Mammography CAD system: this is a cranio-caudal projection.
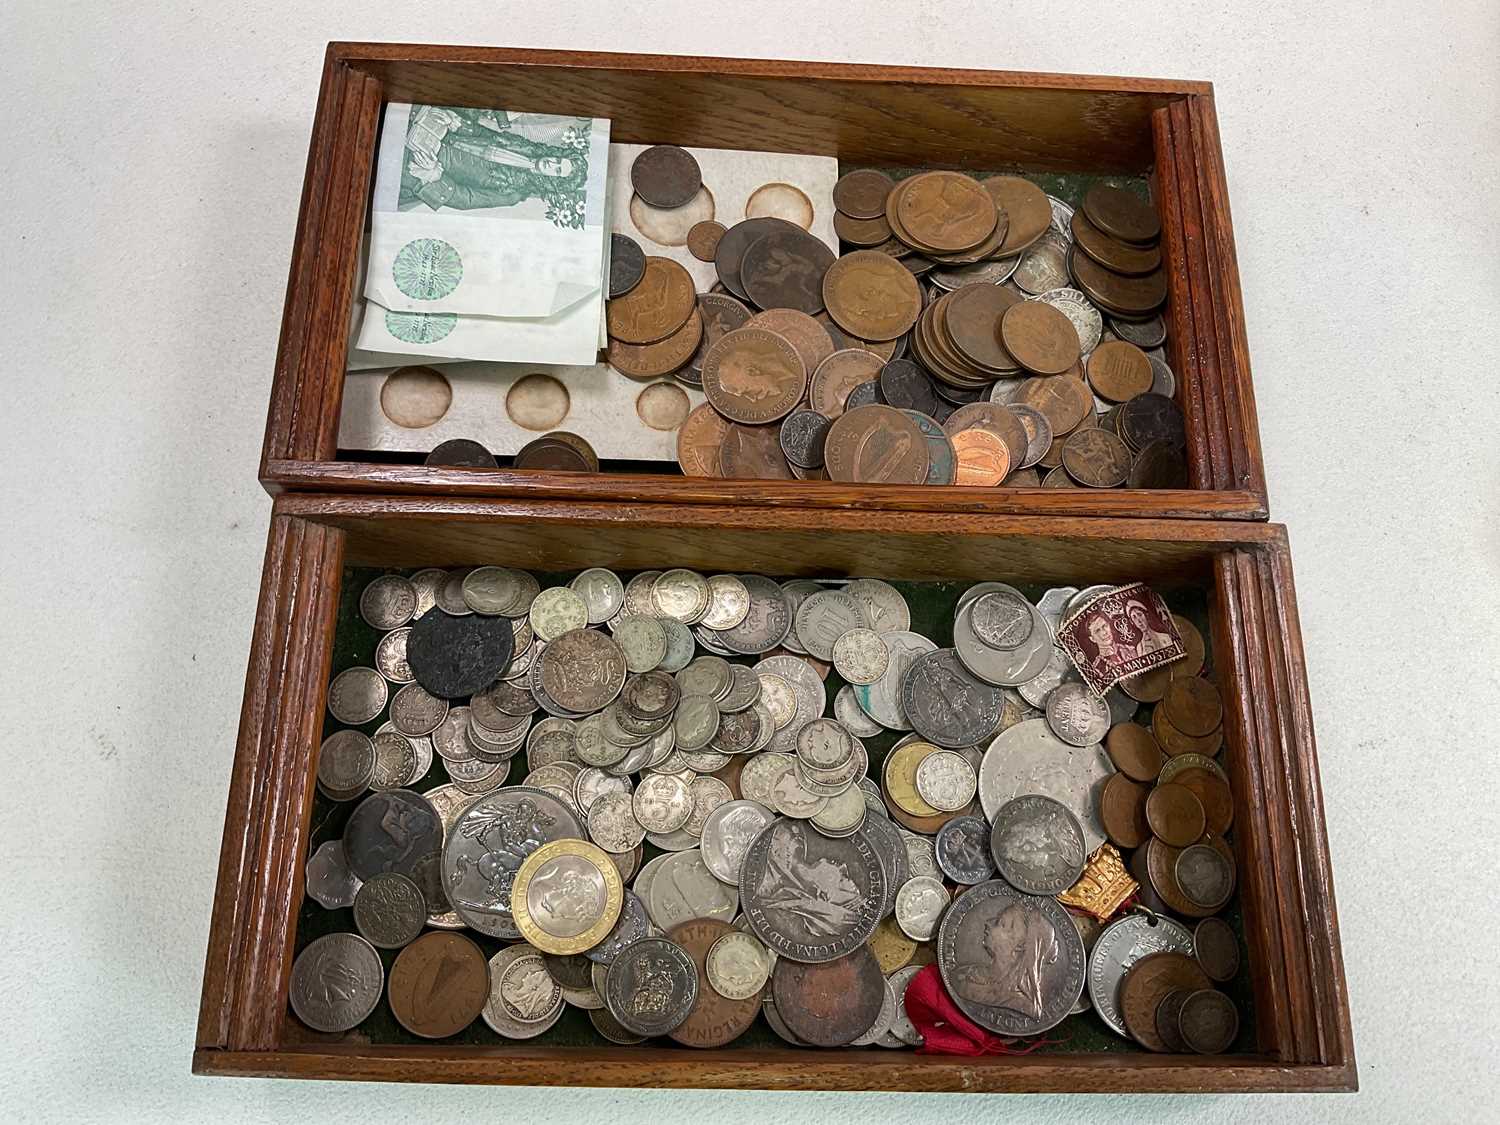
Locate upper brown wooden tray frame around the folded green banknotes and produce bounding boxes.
[261,44,1268,519]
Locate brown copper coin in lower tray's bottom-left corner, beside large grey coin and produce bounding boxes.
[389,932,489,1040]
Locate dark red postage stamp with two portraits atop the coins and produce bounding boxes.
[1058,582,1187,696]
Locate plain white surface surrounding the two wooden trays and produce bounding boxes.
[0,0,1500,1125]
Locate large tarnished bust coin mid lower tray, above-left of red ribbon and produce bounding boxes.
[740,819,887,966]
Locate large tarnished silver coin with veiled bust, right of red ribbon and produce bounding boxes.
[938,879,1086,1035]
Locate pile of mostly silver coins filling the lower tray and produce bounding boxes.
[291,566,1239,1052]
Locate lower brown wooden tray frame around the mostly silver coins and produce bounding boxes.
[194,494,1356,1092]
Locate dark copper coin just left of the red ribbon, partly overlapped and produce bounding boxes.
[771,945,885,1047]
